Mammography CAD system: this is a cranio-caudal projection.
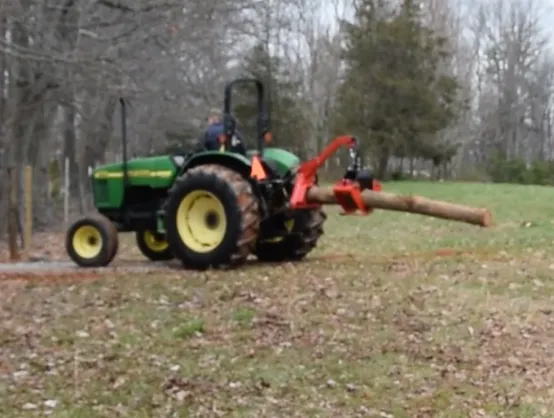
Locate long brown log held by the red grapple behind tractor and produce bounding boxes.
[306,186,492,227]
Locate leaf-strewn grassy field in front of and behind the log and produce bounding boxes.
[4,183,554,418]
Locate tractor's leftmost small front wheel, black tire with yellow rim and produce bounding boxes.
[65,214,119,267]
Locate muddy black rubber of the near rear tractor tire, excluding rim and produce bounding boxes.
[164,164,260,269]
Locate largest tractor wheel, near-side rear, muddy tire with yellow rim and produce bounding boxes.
[165,164,260,270]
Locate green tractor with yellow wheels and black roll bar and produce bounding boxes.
[66,79,326,269]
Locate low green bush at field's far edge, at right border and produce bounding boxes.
[488,159,554,185]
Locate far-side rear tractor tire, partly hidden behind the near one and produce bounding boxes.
[255,208,327,262]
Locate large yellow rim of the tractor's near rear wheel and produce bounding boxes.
[176,190,227,253]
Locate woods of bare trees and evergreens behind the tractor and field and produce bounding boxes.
[0,0,554,235]
